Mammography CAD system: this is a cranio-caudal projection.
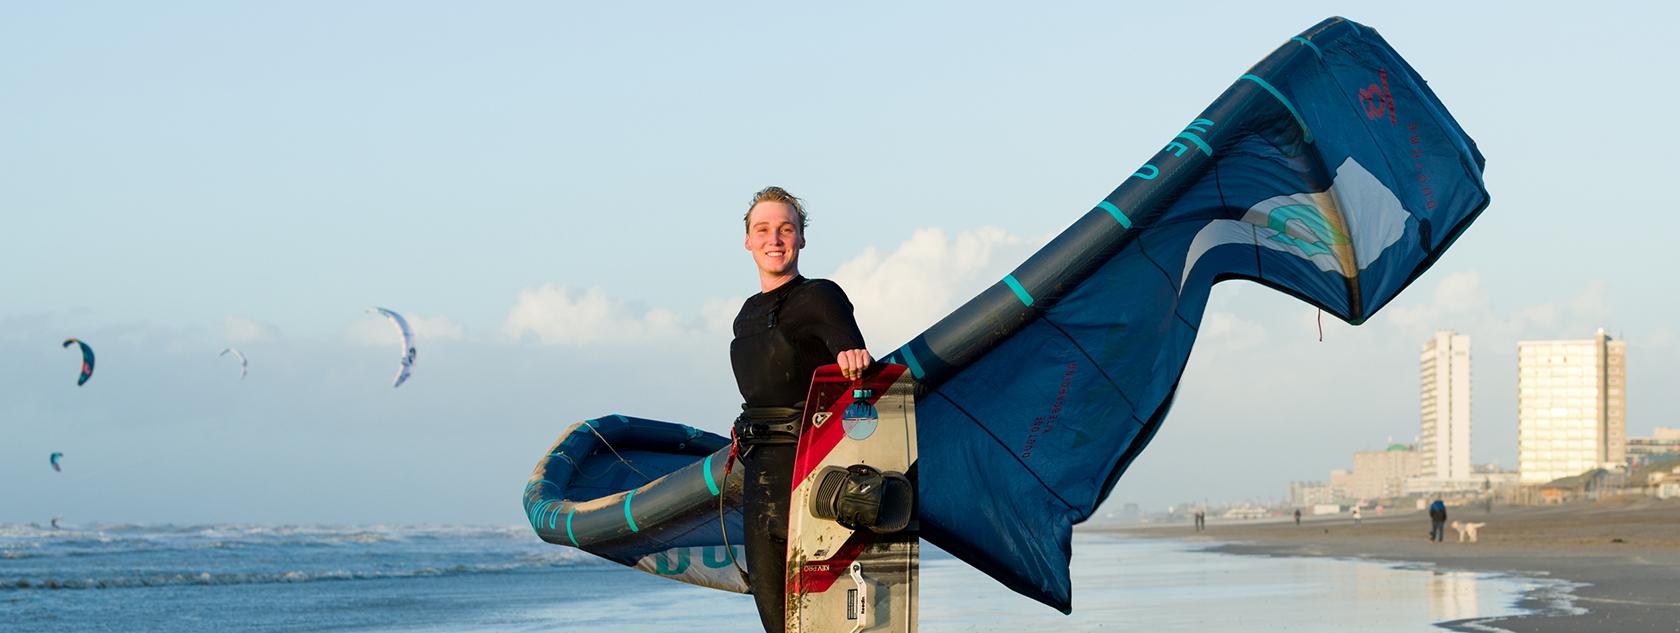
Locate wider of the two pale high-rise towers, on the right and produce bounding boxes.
[1517,329,1628,484]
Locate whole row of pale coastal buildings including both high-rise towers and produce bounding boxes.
[1289,329,1680,507]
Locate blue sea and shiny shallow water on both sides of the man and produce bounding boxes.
[0,524,1567,633]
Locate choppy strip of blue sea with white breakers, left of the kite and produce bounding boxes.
[0,524,606,593]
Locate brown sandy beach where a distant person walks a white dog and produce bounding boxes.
[1102,497,1680,633]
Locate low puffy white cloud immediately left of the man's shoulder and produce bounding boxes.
[502,284,682,344]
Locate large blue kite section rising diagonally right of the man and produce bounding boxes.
[887,18,1488,613]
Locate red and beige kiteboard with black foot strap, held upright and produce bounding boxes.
[786,363,921,633]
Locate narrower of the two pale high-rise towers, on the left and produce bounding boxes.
[1418,331,1470,482]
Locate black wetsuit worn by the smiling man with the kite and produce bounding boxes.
[729,277,864,633]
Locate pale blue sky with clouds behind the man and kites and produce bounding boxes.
[0,2,1680,524]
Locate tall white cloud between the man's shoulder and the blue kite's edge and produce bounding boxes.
[832,227,1025,347]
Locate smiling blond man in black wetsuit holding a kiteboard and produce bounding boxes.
[729,186,874,633]
